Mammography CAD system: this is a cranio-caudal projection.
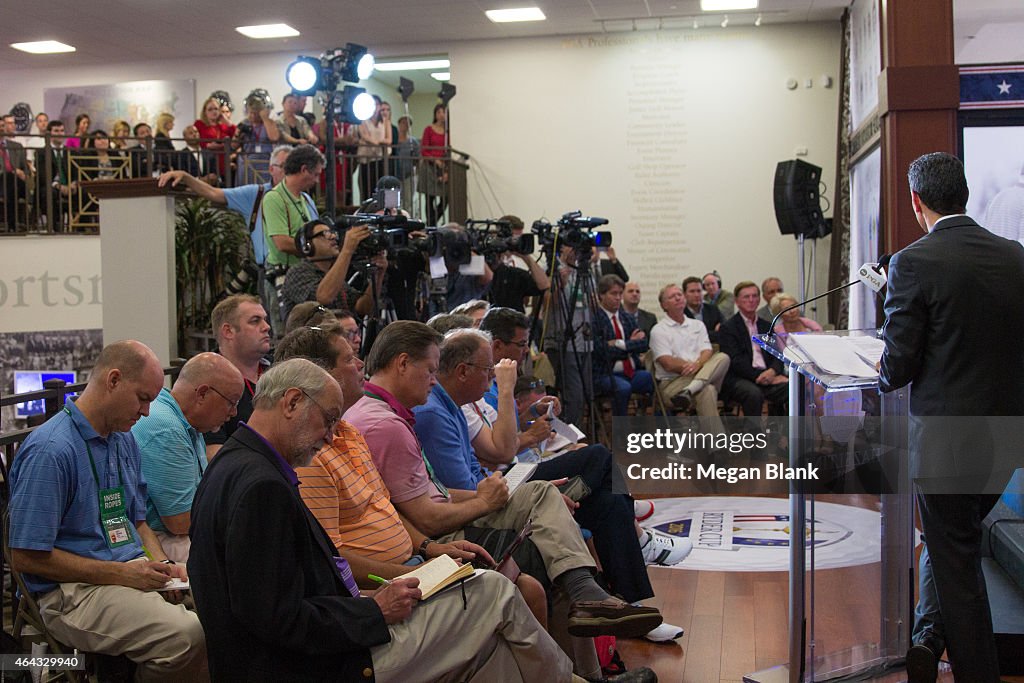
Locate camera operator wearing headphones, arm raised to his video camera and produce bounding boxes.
[281,218,384,319]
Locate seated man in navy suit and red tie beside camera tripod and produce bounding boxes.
[593,275,654,416]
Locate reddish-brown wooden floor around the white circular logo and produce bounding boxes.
[618,497,1024,683]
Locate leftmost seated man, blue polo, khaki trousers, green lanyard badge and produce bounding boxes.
[7,341,207,681]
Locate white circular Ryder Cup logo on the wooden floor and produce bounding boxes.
[644,497,897,571]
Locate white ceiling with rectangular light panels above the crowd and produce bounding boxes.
[0,0,1024,75]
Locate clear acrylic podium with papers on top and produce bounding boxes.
[743,330,914,683]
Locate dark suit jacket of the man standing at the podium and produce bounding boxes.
[879,216,1024,483]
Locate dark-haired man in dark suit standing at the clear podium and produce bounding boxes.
[880,153,1024,683]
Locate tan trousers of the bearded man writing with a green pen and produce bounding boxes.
[370,573,572,683]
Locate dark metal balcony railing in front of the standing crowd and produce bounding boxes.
[0,135,469,233]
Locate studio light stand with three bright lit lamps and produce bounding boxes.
[285,43,376,216]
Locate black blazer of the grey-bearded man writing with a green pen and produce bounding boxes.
[188,427,391,681]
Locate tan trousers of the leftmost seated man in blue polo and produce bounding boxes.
[39,583,209,683]
